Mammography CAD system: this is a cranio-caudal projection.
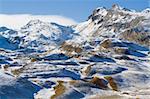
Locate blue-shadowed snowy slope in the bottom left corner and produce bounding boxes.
[0,71,41,99]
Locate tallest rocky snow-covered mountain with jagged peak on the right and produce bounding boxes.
[75,5,150,46]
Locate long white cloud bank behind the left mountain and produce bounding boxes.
[0,14,77,29]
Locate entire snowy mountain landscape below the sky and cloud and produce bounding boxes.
[0,5,150,99]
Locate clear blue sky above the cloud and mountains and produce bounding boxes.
[0,0,150,22]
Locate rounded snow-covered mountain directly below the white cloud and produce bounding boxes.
[19,20,74,50]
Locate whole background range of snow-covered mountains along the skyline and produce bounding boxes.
[0,5,150,50]
